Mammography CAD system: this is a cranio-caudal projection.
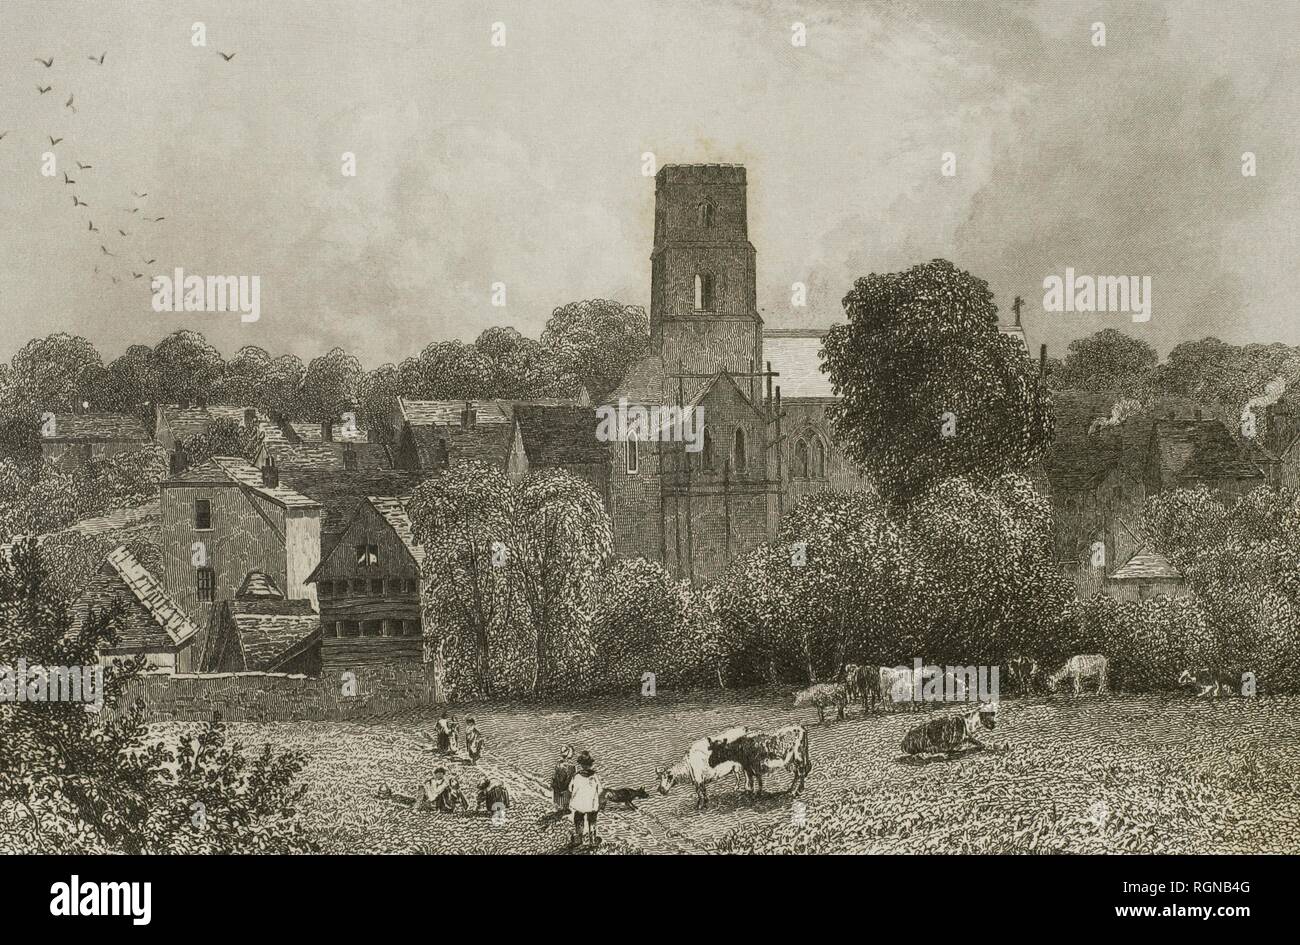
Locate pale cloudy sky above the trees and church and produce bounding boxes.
[0,0,1300,367]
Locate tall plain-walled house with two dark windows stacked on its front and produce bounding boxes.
[160,456,321,628]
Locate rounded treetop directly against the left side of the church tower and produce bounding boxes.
[542,299,650,400]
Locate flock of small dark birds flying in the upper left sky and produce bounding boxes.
[9,51,235,285]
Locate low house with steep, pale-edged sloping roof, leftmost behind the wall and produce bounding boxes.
[73,545,204,673]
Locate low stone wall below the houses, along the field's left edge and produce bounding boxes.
[121,663,433,721]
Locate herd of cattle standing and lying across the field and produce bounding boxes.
[655,654,1240,810]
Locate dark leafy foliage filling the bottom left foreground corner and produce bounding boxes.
[0,539,315,854]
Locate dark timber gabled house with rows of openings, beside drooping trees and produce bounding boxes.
[307,495,424,672]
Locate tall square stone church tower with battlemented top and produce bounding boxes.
[650,164,763,403]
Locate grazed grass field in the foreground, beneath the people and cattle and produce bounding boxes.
[175,692,1300,853]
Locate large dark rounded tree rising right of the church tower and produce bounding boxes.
[824,260,1050,504]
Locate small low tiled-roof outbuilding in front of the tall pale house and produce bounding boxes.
[204,571,321,676]
